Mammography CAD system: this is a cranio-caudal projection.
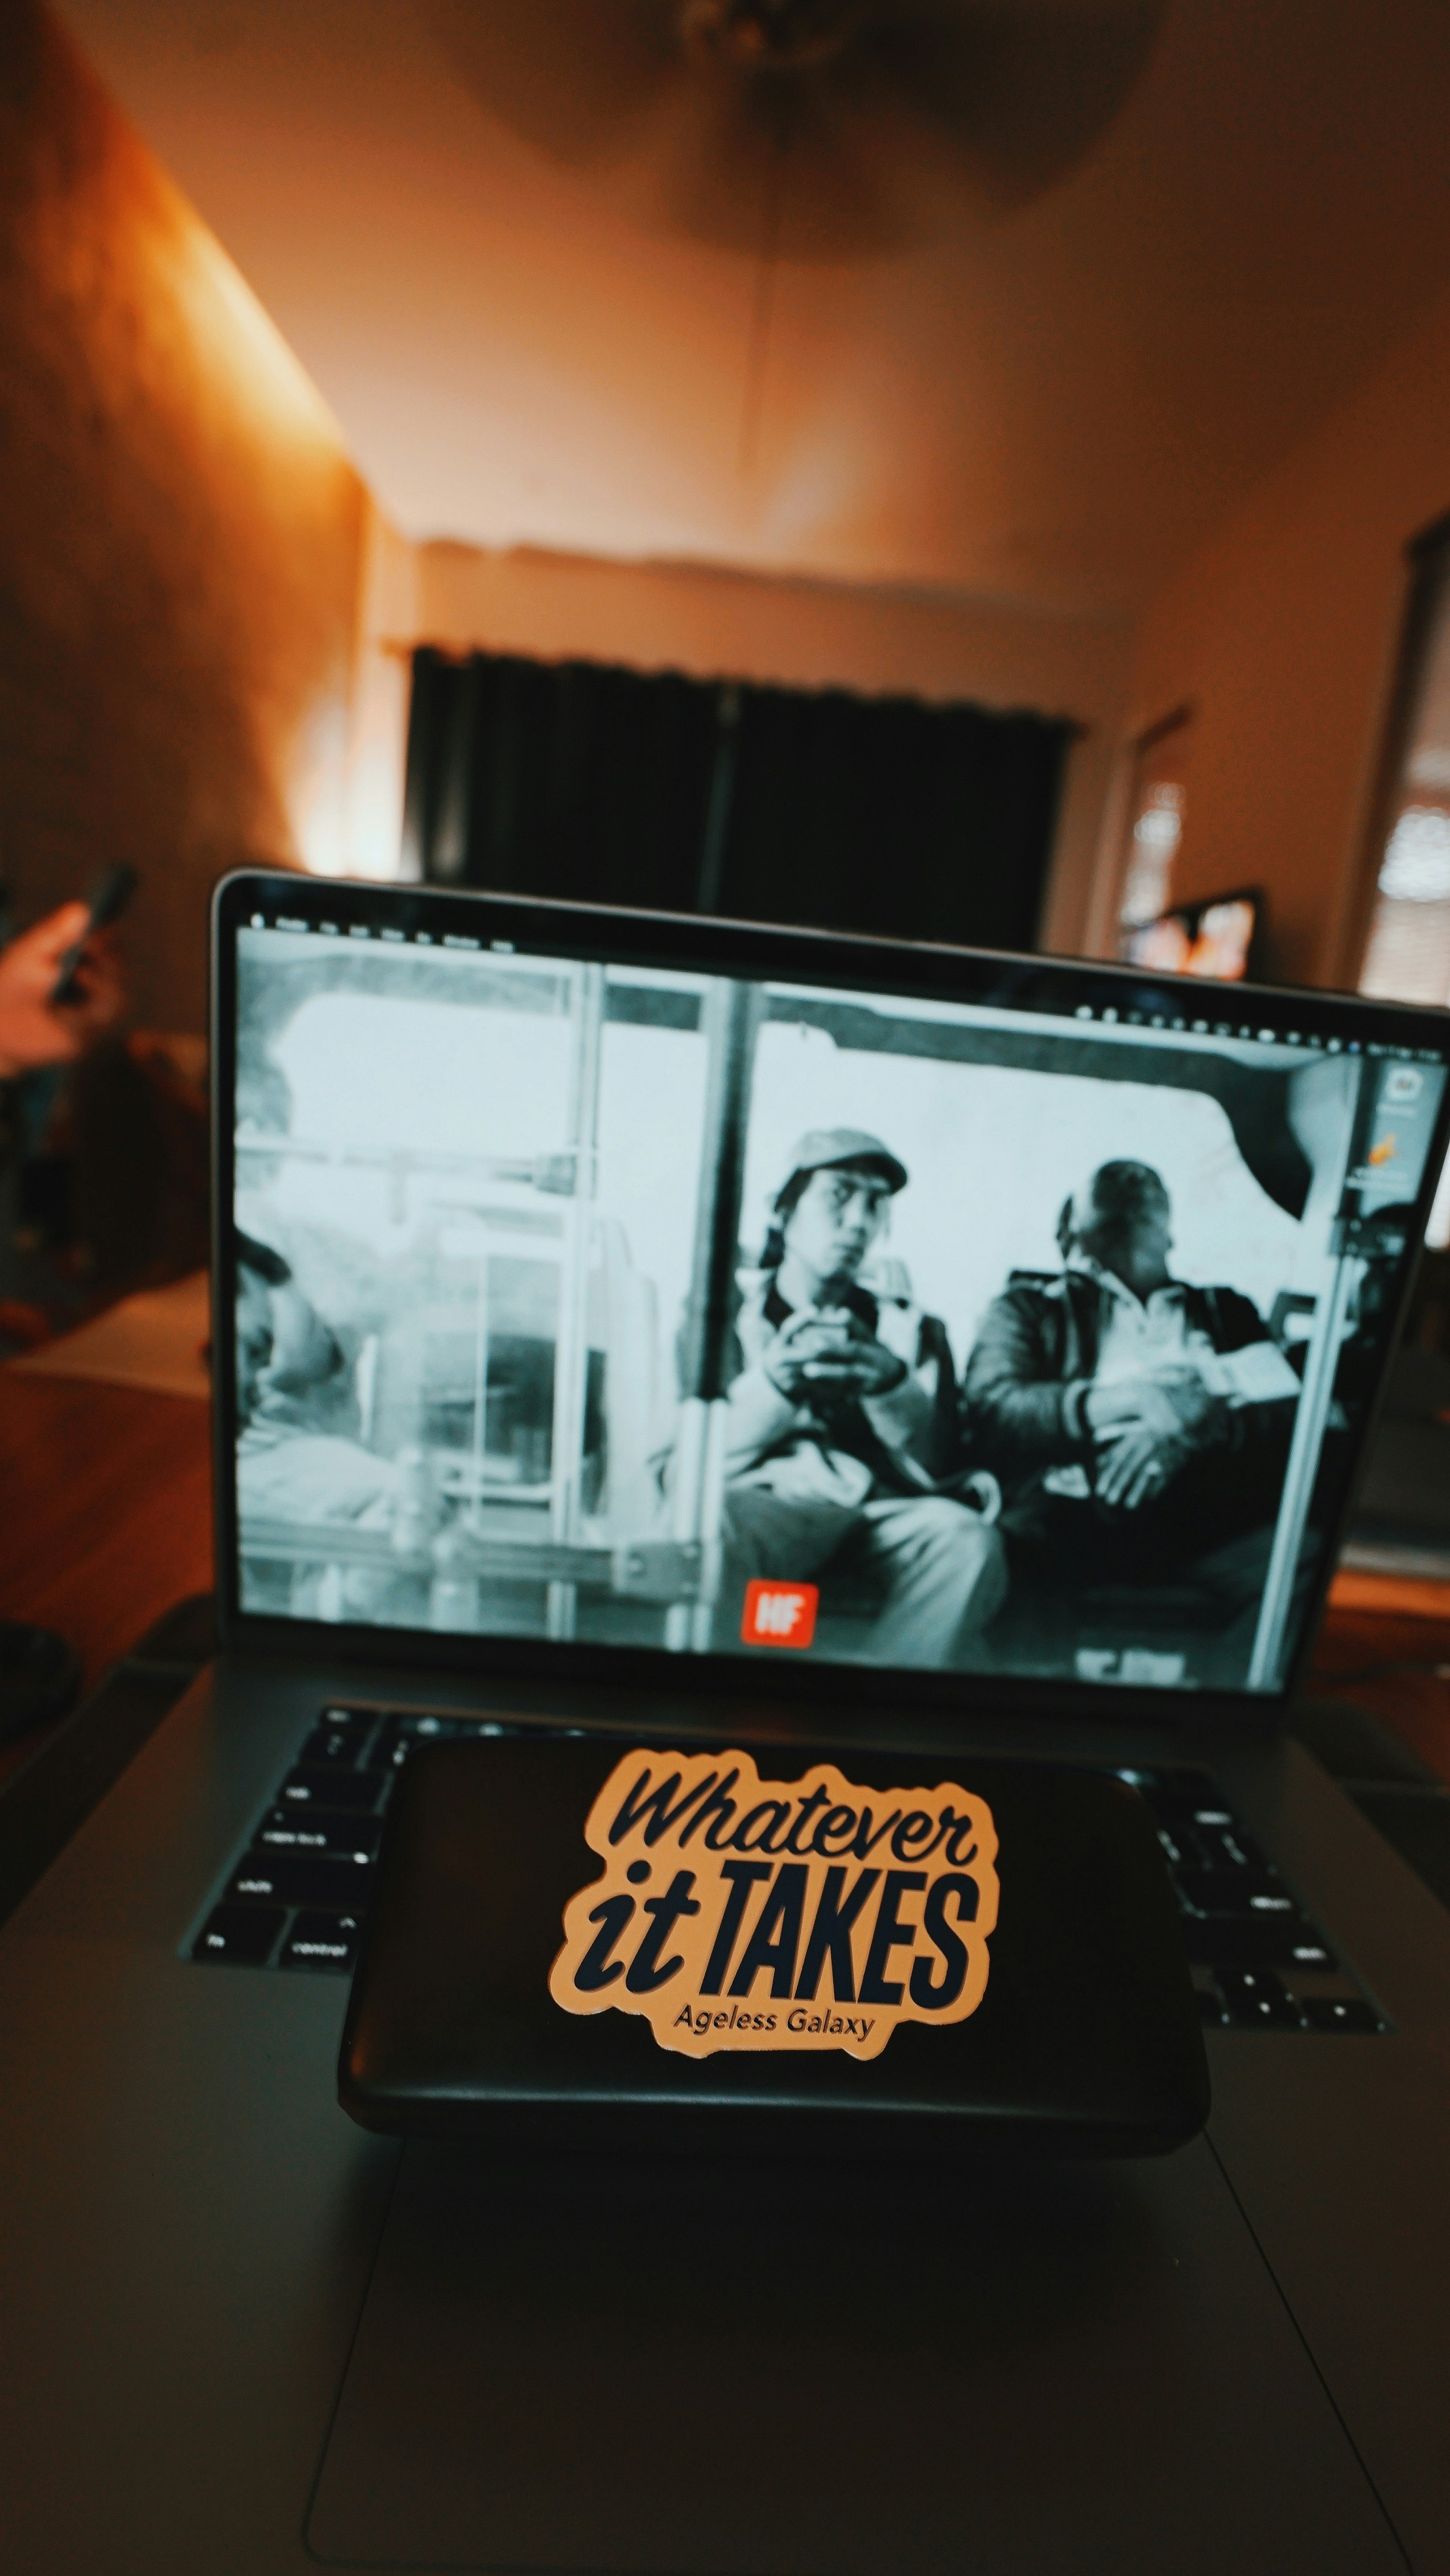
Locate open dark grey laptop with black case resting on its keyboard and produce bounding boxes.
[0,873,1450,2576]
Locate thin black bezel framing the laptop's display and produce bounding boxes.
[211,868,1450,1742]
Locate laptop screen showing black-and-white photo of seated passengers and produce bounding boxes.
[222,878,1445,1695]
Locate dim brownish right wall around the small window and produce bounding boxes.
[1112,272,1450,984]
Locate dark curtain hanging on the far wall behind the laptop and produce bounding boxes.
[404,649,1071,948]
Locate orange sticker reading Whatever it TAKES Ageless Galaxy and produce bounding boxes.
[548,1751,997,2058]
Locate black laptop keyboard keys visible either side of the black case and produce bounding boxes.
[185,1706,1388,2033]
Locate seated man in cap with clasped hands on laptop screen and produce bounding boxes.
[724,1128,1007,1667]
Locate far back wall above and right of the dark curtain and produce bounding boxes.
[415,543,1131,950]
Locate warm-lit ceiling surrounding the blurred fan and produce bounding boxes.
[62,0,1450,616]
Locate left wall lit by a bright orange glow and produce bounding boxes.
[0,0,402,1030]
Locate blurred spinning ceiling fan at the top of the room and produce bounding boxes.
[423,0,1164,262]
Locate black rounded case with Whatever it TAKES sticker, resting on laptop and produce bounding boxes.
[338,1736,1208,2156]
